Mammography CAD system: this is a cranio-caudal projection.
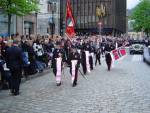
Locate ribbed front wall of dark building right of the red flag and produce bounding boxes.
[72,0,112,28]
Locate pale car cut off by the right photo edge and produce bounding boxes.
[143,47,150,65]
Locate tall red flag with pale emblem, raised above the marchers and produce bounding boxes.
[66,0,75,38]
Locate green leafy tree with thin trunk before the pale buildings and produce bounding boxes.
[0,0,38,35]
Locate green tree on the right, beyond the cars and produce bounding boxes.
[131,0,150,37]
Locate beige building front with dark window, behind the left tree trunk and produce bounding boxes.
[0,11,36,35]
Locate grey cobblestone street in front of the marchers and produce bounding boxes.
[0,55,150,113]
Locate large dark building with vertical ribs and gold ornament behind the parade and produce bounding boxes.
[60,0,126,33]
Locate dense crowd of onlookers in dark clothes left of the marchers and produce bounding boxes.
[0,34,60,89]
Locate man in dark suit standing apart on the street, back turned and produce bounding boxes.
[6,40,23,95]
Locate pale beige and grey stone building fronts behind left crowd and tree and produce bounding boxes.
[0,0,60,35]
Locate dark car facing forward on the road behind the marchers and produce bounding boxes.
[129,40,144,54]
